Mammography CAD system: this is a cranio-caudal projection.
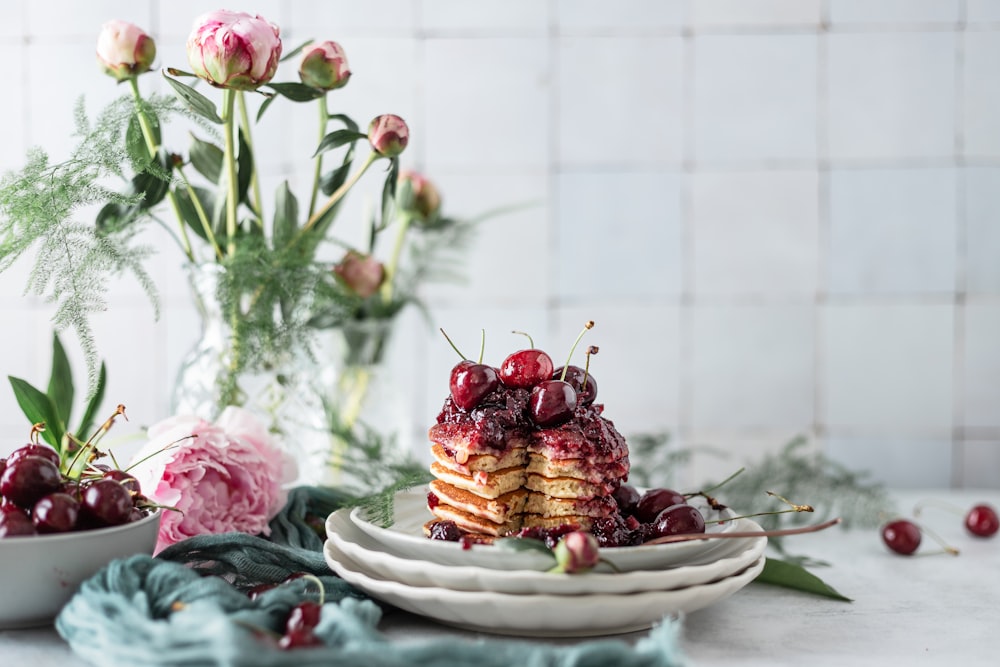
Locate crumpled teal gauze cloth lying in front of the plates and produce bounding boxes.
[56,487,685,667]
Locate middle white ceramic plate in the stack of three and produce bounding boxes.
[326,510,767,595]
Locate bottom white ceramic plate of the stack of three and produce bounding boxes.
[323,541,764,637]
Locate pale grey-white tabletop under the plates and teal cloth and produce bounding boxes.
[0,490,1000,667]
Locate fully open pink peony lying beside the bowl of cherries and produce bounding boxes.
[130,407,295,552]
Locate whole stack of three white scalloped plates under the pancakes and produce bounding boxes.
[324,489,767,637]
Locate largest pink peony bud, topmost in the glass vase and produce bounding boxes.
[187,9,281,90]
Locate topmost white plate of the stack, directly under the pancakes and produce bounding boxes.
[350,487,736,572]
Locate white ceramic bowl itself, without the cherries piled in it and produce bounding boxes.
[0,511,161,630]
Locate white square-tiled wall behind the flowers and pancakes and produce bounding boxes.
[0,0,1000,487]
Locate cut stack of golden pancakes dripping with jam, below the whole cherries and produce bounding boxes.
[425,409,629,537]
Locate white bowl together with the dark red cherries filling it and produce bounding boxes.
[0,442,160,630]
